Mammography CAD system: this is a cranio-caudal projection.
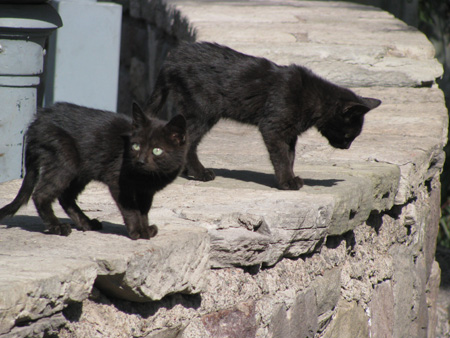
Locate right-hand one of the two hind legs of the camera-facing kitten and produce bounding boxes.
[59,180,102,231]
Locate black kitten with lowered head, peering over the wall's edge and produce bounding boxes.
[146,42,381,190]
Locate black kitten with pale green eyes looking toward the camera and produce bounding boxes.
[0,103,187,239]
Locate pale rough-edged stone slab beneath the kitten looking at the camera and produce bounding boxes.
[0,181,209,333]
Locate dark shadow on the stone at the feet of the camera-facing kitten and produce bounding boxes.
[1,215,128,237]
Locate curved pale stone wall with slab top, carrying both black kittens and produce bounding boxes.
[0,0,448,338]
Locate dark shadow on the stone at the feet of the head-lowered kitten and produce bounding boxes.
[213,168,344,188]
